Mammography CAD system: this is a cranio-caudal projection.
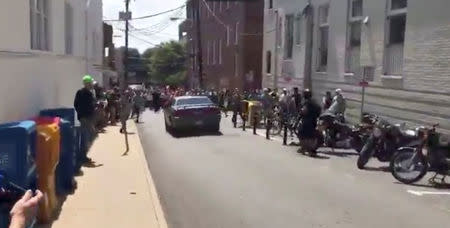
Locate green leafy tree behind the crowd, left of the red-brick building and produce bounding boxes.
[144,41,187,85]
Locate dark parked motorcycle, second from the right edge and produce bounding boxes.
[357,117,420,169]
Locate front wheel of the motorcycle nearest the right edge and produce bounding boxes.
[389,151,428,184]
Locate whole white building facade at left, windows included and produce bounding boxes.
[0,0,103,122]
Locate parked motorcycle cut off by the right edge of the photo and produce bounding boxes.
[390,125,450,184]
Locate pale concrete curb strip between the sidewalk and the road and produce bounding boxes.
[127,121,168,228]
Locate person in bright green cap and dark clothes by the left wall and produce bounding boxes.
[74,75,96,163]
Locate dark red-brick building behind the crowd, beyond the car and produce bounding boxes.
[183,0,264,89]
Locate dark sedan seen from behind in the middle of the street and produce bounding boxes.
[164,96,221,131]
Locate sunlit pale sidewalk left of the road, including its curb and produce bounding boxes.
[40,121,167,228]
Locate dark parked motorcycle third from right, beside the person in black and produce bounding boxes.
[317,113,375,153]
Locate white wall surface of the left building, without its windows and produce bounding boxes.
[0,0,103,123]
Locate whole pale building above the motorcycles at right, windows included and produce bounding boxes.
[263,0,450,133]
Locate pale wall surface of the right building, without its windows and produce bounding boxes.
[263,0,450,134]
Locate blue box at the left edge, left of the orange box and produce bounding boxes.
[0,121,37,189]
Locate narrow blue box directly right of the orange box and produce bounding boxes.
[56,119,76,194]
